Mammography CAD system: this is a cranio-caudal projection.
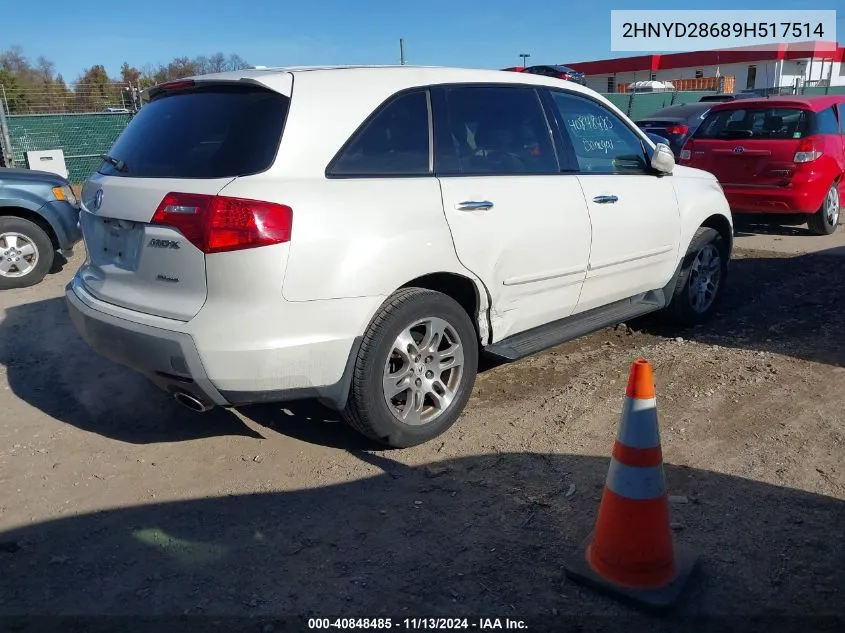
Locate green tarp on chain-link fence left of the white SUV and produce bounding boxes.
[6,113,132,183]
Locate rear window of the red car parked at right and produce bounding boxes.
[695,108,813,140]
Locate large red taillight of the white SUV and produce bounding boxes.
[151,193,293,253]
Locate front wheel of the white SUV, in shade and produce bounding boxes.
[668,226,729,325]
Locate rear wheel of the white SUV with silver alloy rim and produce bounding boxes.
[343,288,478,448]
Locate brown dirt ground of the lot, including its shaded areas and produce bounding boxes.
[0,231,845,632]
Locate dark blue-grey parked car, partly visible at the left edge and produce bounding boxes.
[0,168,82,290]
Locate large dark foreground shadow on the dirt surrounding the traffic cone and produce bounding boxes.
[0,453,845,631]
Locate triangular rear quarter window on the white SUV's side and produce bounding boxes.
[328,90,429,177]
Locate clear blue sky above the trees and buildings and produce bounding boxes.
[0,0,845,82]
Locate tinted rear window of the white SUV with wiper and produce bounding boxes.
[99,86,289,178]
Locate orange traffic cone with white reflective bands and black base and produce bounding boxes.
[566,360,698,609]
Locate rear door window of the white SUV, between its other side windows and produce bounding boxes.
[436,86,558,175]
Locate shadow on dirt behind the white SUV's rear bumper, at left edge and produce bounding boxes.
[0,297,260,444]
